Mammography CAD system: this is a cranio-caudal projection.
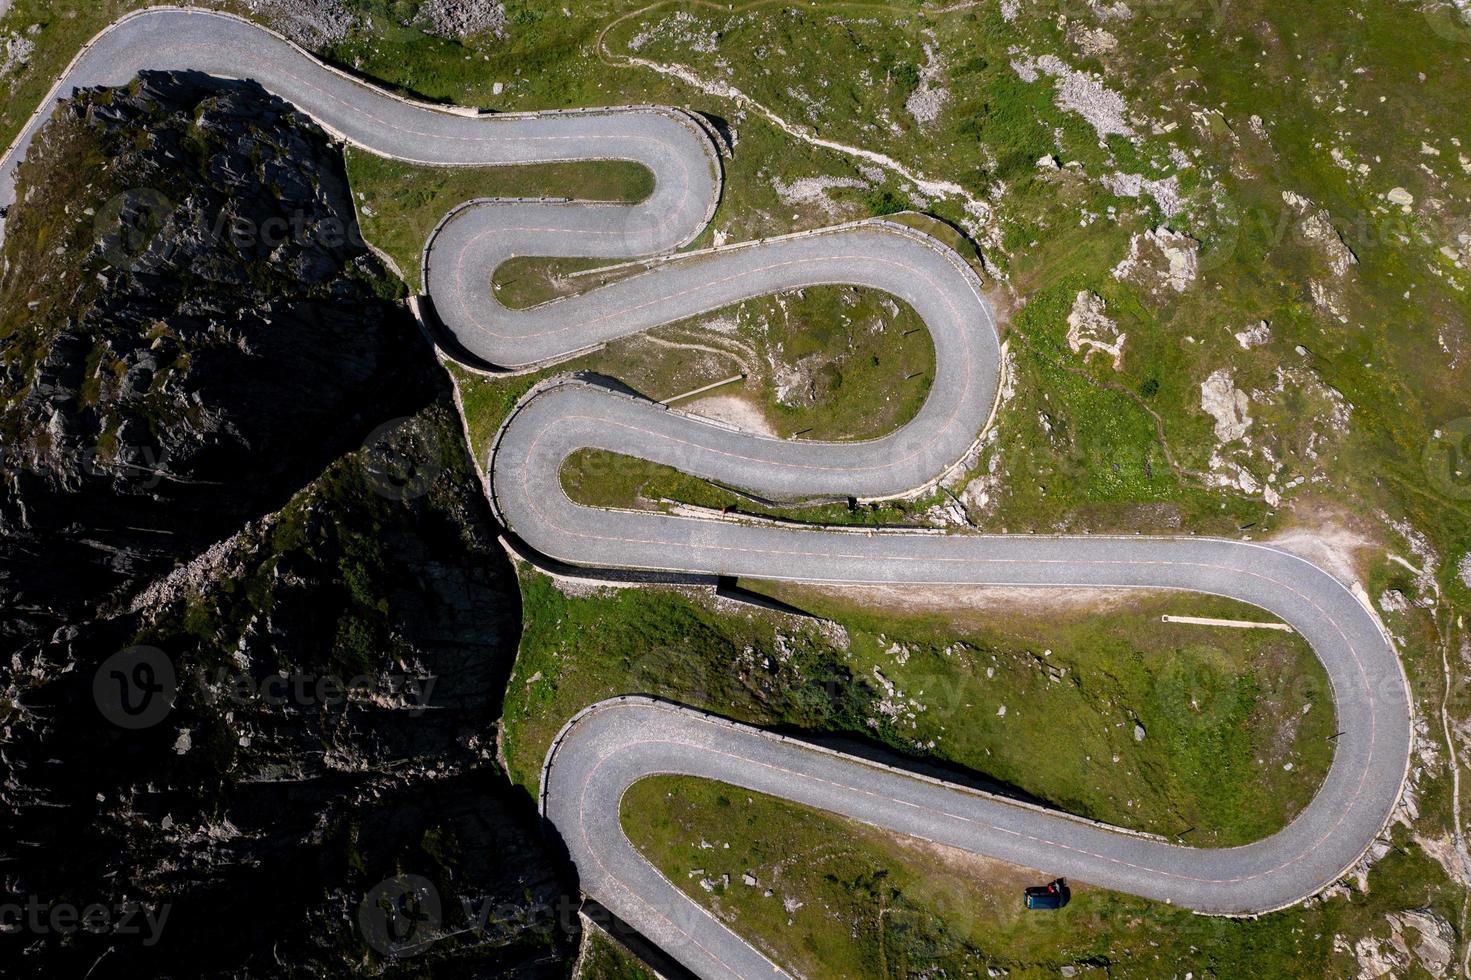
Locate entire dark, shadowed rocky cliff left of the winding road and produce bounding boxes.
[0,75,577,977]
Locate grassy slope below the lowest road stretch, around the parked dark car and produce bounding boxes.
[622,777,1461,977]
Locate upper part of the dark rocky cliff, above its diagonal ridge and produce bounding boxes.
[0,75,435,647]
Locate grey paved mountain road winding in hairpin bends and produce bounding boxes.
[0,9,1411,977]
